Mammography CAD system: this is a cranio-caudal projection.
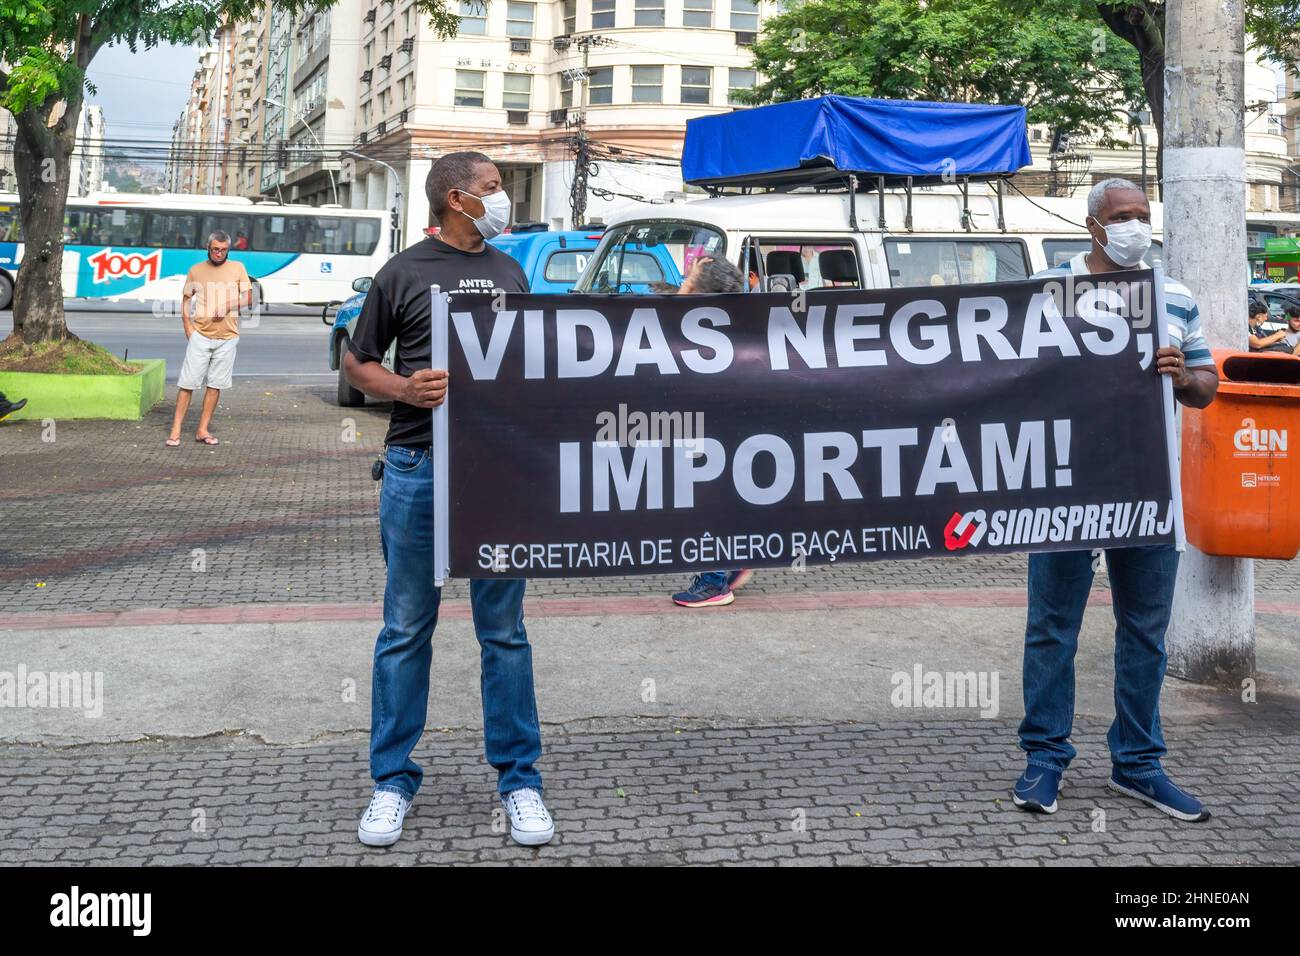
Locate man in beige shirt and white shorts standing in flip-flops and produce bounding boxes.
[166,232,252,446]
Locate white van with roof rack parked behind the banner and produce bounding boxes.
[575,183,1162,294]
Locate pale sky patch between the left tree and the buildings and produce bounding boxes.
[87,46,199,170]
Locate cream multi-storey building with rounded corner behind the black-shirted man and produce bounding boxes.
[351,0,775,242]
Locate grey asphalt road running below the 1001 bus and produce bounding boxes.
[0,302,337,384]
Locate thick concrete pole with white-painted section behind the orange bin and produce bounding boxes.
[1164,0,1255,684]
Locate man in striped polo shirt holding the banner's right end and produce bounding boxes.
[1011,179,1218,822]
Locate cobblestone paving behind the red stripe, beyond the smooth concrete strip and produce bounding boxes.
[0,385,1300,613]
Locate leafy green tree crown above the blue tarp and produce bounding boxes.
[746,0,1143,143]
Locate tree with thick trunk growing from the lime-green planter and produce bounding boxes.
[0,0,460,342]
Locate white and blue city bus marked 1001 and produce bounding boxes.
[0,193,391,308]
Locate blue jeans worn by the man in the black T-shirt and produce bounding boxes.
[371,445,542,797]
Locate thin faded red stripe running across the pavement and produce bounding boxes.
[0,588,1300,631]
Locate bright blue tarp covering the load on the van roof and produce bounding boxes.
[681,96,1030,186]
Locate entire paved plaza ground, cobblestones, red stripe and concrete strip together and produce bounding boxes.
[0,385,1300,865]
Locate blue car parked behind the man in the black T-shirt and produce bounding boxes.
[321,228,601,408]
